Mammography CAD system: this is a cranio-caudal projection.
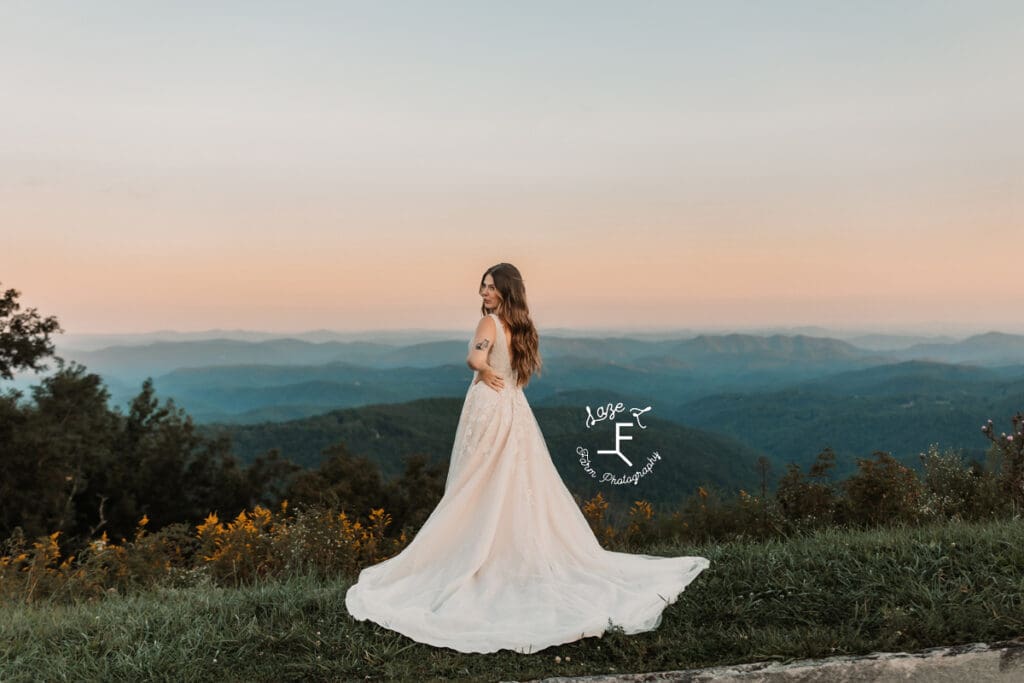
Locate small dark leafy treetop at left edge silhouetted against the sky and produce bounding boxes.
[0,282,63,380]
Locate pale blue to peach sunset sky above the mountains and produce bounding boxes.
[0,0,1024,334]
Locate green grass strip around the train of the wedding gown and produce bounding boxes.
[0,520,1024,681]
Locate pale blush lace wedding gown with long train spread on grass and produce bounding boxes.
[345,313,709,653]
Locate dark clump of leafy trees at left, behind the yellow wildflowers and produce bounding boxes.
[0,366,258,547]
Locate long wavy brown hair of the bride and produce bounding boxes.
[480,263,544,387]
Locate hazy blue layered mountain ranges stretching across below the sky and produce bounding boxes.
[54,333,1024,485]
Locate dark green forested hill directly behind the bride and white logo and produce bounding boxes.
[202,398,761,506]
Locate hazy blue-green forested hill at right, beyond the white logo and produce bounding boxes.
[670,360,1024,474]
